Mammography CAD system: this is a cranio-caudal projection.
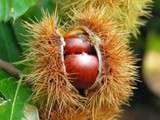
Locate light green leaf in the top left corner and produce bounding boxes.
[0,0,38,21]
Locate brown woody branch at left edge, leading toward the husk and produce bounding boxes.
[0,59,21,77]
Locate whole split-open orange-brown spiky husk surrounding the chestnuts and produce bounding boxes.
[26,7,136,120]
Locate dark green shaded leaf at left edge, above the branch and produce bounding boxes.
[0,22,20,62]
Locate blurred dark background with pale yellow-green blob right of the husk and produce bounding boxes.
[122,0,160,120]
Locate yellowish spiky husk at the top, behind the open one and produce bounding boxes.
[57,0,152,36]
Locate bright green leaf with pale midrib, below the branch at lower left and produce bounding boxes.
[0,78,31,120]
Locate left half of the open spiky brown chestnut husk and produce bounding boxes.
[25,13,84,120]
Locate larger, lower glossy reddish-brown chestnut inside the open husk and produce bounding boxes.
[65,53,99,89]
